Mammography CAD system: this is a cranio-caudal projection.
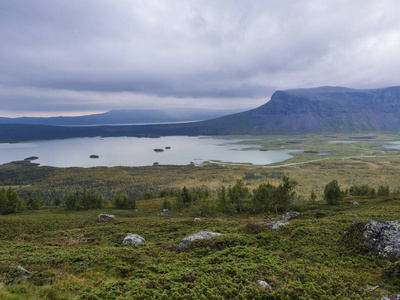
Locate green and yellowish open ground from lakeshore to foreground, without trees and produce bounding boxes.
[0,134,400,299]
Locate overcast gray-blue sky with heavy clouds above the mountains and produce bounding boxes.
[0,0,400,117]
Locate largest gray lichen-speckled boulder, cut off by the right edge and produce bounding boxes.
[364,220,400,258]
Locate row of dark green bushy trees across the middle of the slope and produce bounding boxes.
[0,176,400,215]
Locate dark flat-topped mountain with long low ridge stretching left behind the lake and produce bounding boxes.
[0,87,400,142]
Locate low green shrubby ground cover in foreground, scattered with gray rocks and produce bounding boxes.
[0,198,400,299]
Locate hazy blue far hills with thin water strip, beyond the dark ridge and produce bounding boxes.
[0,108,247,126]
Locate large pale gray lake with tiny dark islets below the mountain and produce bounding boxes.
[0,136,299,167]
